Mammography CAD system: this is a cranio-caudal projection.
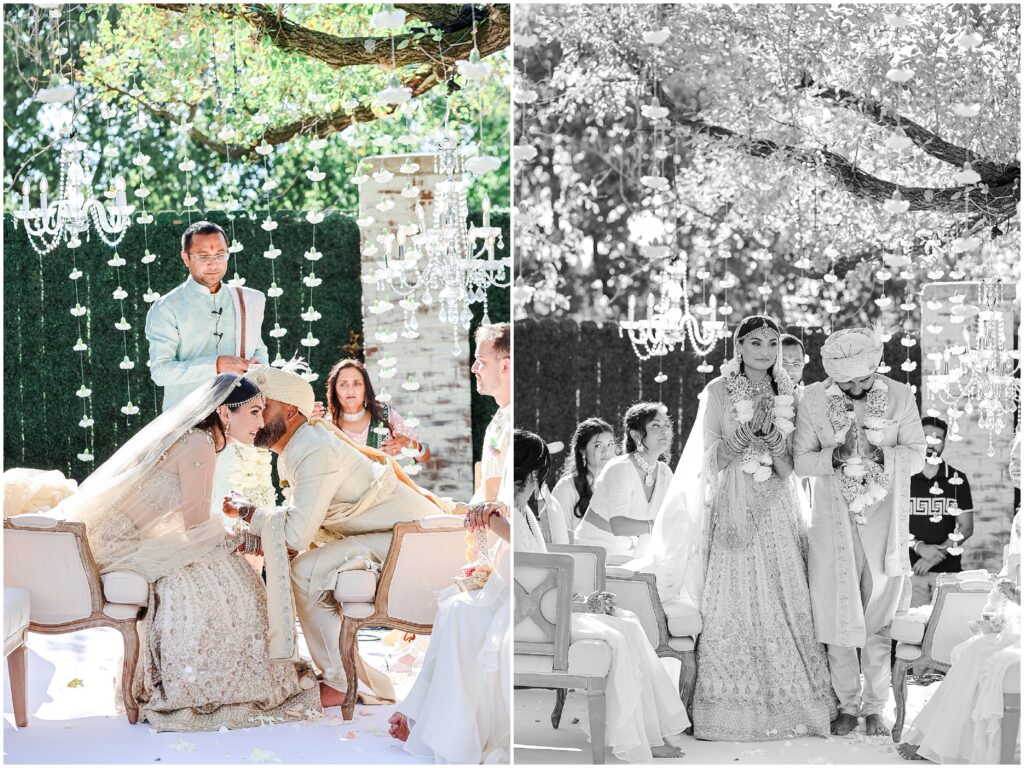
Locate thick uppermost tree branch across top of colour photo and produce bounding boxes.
[151,3,511,70]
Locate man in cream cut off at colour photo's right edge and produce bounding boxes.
[472,323,512,503]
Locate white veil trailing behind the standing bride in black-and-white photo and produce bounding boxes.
[626,388,717,610]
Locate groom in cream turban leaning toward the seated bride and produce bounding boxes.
[240,365,465,707]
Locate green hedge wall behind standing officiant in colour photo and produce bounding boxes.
[3,211,509,480]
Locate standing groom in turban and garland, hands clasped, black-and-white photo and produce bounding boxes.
[794,329,925,735]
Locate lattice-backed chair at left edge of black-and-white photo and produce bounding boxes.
[513,550,611,764]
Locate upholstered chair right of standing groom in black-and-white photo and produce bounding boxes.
[889,573,995,742]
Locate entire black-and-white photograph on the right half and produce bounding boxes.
[512,3,1021,765]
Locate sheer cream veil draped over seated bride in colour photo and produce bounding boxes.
[53,374,242,581]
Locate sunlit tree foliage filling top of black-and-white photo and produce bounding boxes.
[514,4,1020,328]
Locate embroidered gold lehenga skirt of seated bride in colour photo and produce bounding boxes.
[134,548,322,731]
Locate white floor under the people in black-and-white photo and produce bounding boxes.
[513,659,937,765]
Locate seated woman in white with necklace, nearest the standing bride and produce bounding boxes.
[575,402,672,564]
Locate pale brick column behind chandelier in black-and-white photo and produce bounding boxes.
[921,283,1017,572]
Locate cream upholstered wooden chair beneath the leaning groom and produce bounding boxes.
[334,515,479,720]
